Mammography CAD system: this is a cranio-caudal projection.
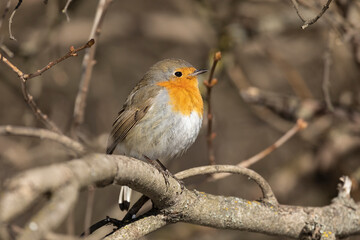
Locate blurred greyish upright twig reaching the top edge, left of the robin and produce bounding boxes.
[71,0,112,138]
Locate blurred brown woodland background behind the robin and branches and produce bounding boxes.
[0,0,360,240]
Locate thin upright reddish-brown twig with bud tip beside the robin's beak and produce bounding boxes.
[204,52,221,165]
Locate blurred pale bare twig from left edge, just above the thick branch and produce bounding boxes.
[0,125,85,154]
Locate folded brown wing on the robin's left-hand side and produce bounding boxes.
[106,81,161,154]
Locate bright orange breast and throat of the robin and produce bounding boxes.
[157,77,203,116]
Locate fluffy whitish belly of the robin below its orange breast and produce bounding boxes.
[115,89,202,162]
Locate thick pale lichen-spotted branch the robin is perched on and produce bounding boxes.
[0,154,360,239]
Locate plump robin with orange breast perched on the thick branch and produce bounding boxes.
[106,59,206,210]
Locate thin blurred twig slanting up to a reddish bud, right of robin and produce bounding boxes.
[209,119,307,181]
